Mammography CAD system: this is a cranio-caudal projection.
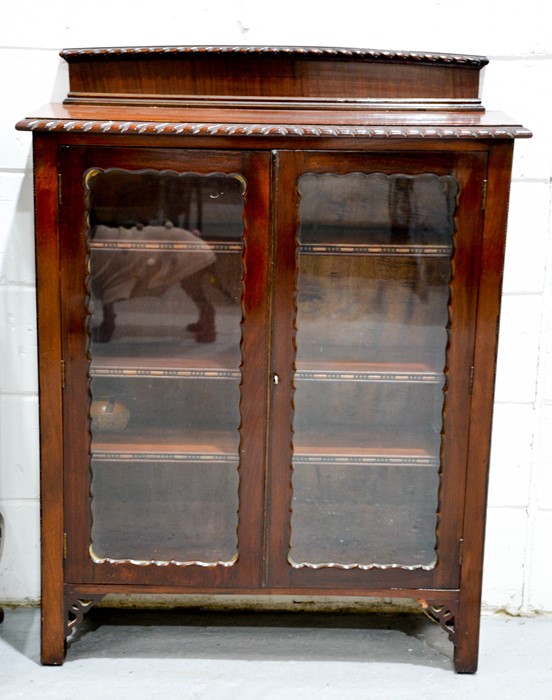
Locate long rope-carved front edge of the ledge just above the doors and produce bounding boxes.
[16,119,531,140]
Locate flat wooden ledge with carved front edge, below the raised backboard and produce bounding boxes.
[17,103,531,140]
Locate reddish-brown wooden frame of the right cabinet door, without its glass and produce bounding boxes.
[267,152,486,588]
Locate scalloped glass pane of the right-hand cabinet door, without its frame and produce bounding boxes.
[289,173,458,568]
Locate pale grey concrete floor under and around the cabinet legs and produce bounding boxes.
[0,608,552,700]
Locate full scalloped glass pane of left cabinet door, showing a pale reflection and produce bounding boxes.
[85,169,245,565]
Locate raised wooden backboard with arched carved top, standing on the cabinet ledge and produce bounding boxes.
[58,47,487,104]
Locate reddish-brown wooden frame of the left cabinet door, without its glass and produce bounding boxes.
[59,146,270,590]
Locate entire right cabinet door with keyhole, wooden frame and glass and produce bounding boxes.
[266,152,486,590]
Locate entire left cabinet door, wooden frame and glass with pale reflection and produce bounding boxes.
[59,147,269,587]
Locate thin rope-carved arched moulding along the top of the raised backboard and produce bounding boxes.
[59,46,489,68]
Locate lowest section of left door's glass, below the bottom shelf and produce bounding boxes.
[92,459,237,561]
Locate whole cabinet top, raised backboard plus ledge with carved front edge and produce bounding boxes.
[17,46,530,138]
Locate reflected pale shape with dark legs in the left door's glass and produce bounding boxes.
[90,221,216,343]
